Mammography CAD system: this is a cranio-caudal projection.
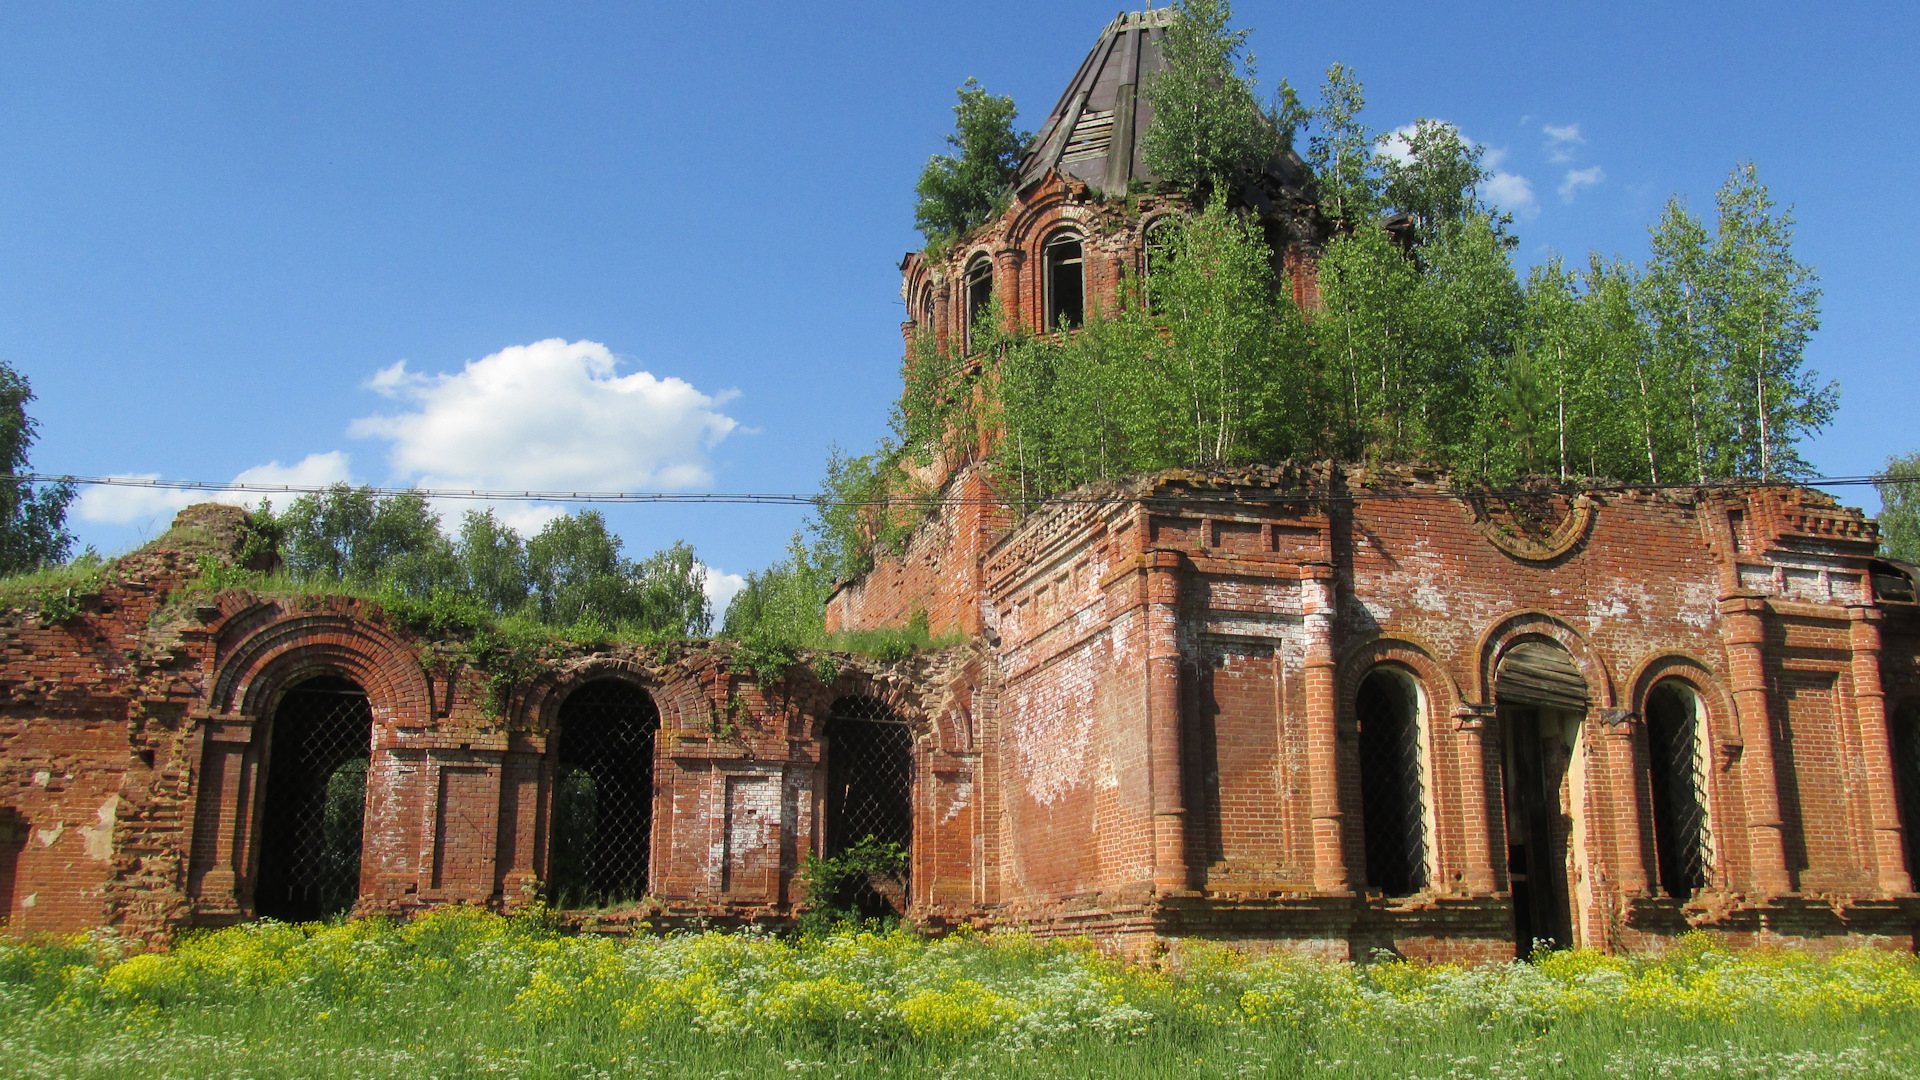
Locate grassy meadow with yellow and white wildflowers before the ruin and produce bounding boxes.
[0,909,1920,1080]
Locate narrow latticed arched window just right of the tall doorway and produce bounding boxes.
[1645,680,1713,899]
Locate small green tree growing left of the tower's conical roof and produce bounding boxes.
[914,79,1033,246]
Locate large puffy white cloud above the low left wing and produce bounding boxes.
[348,338,737,490]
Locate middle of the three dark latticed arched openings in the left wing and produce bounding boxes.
[549,678,660,909]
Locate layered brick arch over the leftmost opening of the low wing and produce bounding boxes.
[207,601,434,724]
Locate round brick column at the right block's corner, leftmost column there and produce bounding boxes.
[1146,552,1192,894]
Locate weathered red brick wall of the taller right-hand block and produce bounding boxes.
[835,467,1920,959]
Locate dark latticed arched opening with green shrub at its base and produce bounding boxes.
[826,698,914,917]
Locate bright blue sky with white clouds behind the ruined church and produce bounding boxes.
[0,0,1920,595]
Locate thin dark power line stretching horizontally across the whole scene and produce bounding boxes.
[12,473,1920,507]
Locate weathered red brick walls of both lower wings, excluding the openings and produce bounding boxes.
[11,465,1920,959]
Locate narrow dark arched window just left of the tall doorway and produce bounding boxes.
[1354,667,1427,896]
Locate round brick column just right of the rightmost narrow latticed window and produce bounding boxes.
[1720,594,1793,897]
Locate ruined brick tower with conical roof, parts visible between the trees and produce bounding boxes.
[828,10,1331,634]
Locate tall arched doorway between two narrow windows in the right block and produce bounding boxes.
[1494,640,1588,957]
